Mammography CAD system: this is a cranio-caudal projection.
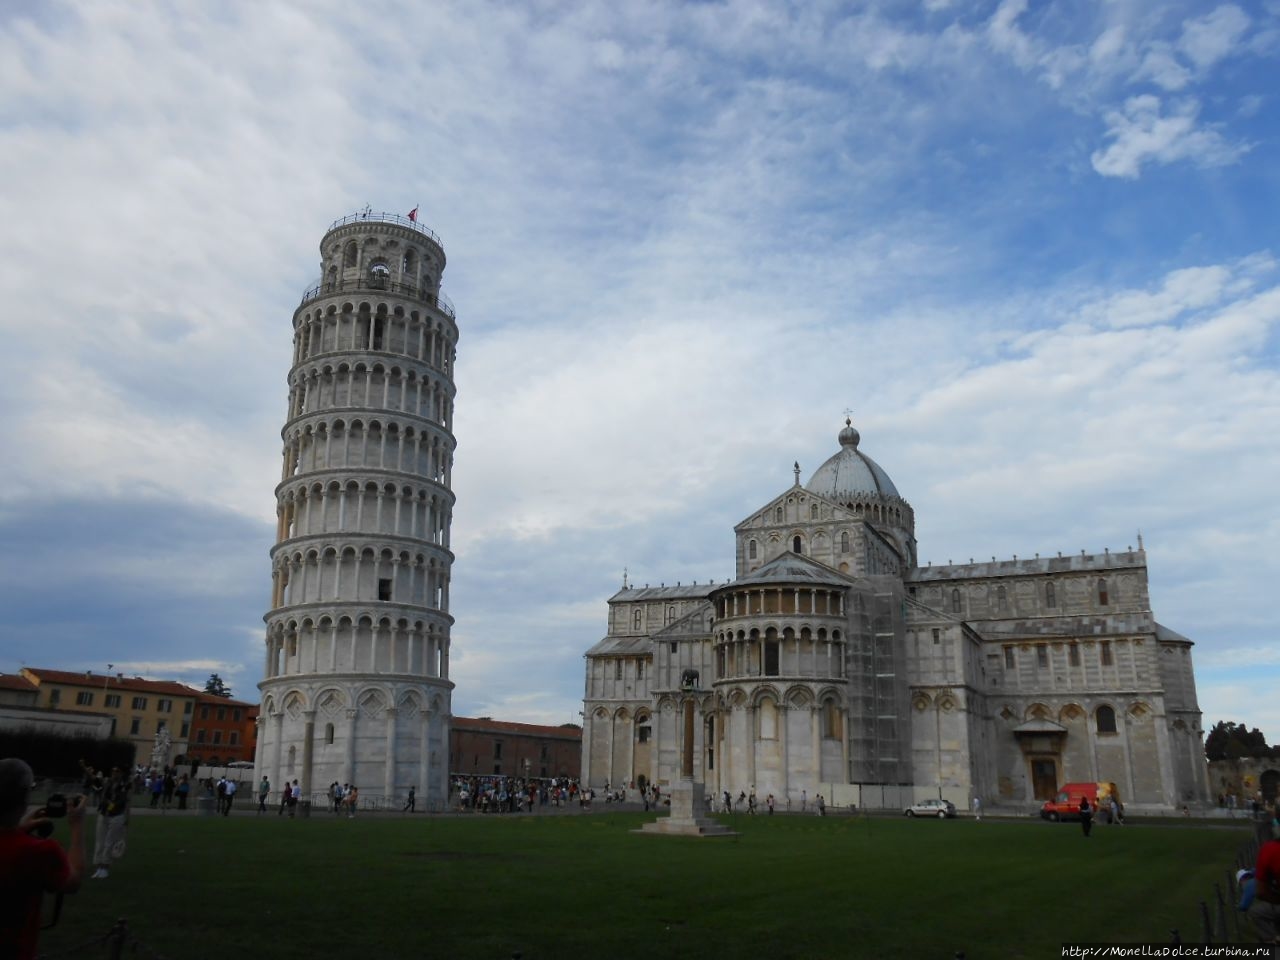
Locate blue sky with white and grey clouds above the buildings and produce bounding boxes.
[0,0,1280,742]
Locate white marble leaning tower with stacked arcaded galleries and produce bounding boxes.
[255,211,458,805]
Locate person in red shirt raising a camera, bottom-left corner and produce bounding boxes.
[0,758,84,960]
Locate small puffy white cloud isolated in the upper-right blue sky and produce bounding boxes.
[1091,93,1249,179]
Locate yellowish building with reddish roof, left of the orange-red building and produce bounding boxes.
[22,667,200,763]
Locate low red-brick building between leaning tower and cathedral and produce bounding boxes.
[449,717,582,780]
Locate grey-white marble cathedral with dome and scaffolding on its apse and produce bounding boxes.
[582,420,1208,810]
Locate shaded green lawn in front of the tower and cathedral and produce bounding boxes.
[41,812,1249,960]
